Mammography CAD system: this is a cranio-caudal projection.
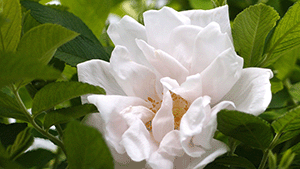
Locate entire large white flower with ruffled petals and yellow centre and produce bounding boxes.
[78,6,273,169]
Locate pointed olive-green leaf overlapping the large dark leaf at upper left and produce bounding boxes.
[17,23,79,65]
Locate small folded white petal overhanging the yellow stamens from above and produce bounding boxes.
[160,73,202,103]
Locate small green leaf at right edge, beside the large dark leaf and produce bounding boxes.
[272,106,300,133]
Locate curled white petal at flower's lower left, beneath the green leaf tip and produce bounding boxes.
[88,95,149,154]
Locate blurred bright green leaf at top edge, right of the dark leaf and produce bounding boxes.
[60,0,113,37]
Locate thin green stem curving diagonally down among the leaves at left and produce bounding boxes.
[11,85,66,154]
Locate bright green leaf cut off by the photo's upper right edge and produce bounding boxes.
[261,2,300,67]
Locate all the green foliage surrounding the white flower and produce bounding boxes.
[0,0,300,169]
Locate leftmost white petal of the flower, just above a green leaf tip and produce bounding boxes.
[77,60,125,95]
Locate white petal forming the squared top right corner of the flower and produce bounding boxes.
[181,5,231,37]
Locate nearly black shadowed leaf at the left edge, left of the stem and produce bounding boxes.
[0,123,27,147]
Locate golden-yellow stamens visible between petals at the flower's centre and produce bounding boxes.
[145,91,190,132]
